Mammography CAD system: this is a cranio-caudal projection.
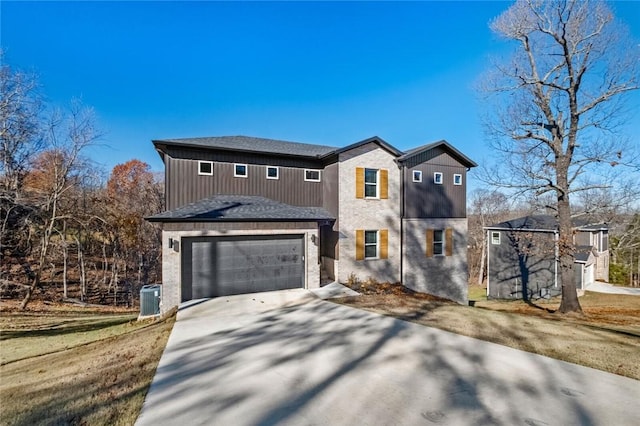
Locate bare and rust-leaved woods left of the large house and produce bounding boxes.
[0,57,163,309]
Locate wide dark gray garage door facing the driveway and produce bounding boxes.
[182,235,304,301]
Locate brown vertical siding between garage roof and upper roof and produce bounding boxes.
[165,156,323,210]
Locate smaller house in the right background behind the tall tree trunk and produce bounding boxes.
[484,215,609,300]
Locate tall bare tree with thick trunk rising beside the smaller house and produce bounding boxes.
[484,0,640,313]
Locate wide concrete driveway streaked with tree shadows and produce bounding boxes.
[136,290,640,426]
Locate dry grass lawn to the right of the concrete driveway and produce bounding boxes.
[335,282,640,380]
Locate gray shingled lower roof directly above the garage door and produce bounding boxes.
[147,195,335,222]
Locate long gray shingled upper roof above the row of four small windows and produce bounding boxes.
[153,136,338,158]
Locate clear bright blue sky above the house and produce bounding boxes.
[0,0,640,186]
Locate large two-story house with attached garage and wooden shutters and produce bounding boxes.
[148,136,476,311]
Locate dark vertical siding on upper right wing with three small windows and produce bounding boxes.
[403,153,467,219]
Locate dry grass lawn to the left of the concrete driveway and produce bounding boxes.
[0,302,175,425]
